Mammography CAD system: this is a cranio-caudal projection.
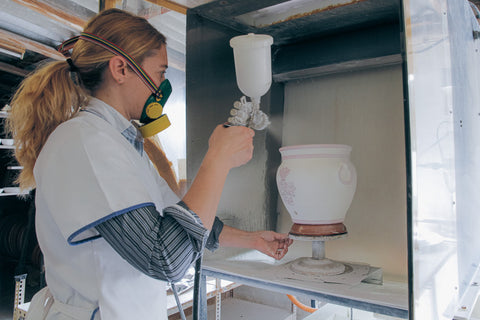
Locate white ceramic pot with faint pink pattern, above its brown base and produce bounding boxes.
[277,144,357,232]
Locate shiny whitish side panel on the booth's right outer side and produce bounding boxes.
[403,0,480,319]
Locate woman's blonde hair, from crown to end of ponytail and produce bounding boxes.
[7,9,166,189]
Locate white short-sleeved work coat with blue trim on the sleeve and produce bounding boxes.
[29,99,179,320]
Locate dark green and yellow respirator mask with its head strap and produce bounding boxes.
[58,32,172,138]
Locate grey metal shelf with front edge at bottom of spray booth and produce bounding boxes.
[200,250,408,319]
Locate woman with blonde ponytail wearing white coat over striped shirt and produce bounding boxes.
[9,9,291,320]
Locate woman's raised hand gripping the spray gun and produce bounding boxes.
[208,125,255,169]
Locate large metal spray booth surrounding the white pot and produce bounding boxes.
[186,0,480,320]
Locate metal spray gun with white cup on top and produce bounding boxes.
[228,33,273,130]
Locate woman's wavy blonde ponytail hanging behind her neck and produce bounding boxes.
[7,61,87,189]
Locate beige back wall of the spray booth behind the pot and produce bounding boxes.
[277,65,408,282]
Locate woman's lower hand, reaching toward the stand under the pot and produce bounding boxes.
[252,231,293,260]
